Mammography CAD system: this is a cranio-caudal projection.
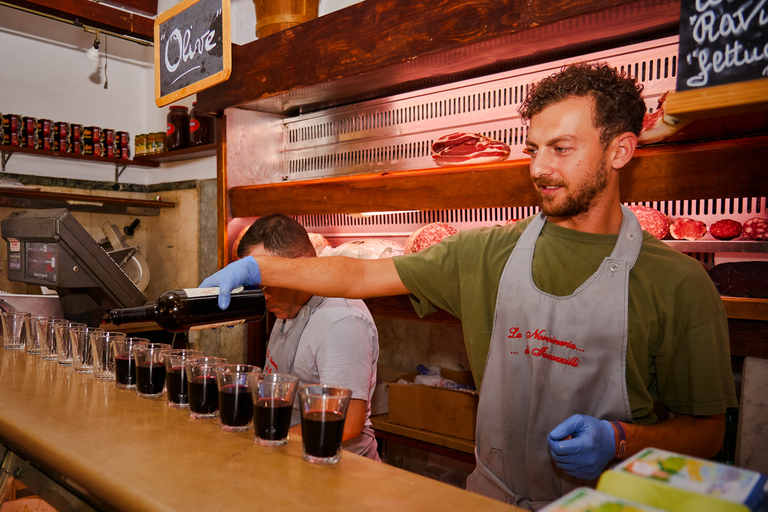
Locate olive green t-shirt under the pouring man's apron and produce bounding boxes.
[394,218,737,424]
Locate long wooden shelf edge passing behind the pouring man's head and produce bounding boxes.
[229,136,768,217]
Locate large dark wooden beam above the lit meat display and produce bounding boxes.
[197,0,680,115]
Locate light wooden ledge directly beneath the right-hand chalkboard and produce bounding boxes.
[664,78,768,120]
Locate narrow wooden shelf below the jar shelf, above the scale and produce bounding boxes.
[0,187,176,216]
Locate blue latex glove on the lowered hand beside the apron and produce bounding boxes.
[547,414,616,480]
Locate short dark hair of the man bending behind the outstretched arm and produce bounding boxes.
[237,213,317,258]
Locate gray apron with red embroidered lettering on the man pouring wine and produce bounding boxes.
[467,206,643,510]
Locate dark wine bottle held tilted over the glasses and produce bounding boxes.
[106,288,266,332]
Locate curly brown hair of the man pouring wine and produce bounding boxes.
[518,62,646,146]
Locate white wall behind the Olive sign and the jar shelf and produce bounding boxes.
[0,0,364,185]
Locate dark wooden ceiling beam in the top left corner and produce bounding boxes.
[5,0,155,42]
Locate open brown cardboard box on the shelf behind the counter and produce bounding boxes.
[389,370,478,439]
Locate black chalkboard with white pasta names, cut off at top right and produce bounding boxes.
[677,0,768,91]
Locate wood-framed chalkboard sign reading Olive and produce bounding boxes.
[155,0,232,107]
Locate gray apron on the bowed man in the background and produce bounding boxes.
[264,295,325,374]
